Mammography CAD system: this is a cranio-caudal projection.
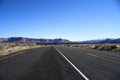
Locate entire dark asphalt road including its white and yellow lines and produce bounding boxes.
[0,47,120,80]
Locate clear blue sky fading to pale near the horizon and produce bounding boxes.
[0,0,120,41]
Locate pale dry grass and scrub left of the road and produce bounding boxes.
[0,43,41,57]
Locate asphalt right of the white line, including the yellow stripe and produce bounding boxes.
[58,47,120,80]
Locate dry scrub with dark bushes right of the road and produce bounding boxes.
[64,44,120,53]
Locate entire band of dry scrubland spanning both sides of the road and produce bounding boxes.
[0,42,120,57]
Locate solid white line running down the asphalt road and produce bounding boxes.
[54,46,89,80]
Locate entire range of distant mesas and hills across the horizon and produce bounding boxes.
[0,37,120,44]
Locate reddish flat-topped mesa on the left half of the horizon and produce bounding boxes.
[0,37,70,43]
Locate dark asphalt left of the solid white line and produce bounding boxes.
[0,47,84,80]
